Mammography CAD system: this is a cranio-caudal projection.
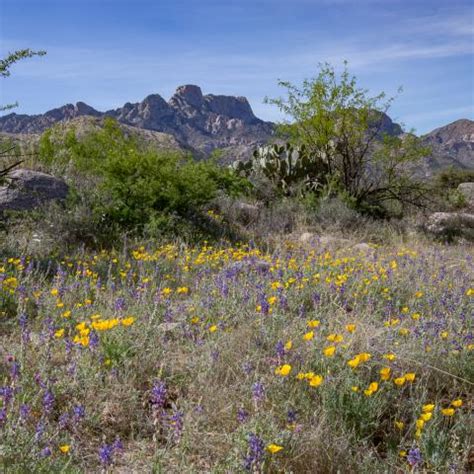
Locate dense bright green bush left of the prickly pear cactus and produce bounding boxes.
[39,118,245,237]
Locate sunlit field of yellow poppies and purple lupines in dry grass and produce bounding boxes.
[0,242,474,473]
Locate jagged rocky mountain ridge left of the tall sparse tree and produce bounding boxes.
[0,85,274,158]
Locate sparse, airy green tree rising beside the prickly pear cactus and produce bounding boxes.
[266,62,429,213]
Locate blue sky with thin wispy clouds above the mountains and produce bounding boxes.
[0,0,474,133]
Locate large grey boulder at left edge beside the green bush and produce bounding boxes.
[0,168,69,212]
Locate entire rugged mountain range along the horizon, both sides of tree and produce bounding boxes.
[0,85,474,175]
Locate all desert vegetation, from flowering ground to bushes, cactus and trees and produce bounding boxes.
[0,50,474,473]
